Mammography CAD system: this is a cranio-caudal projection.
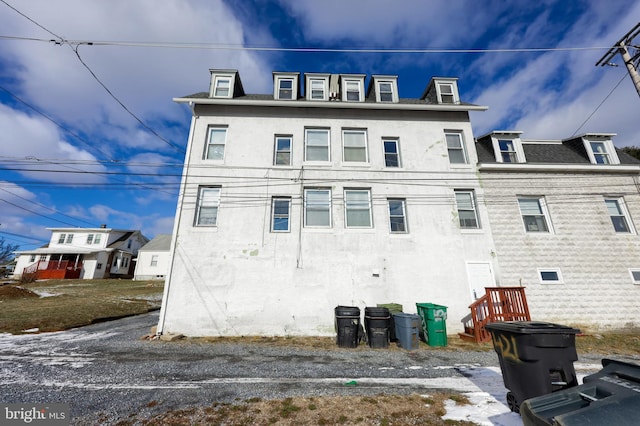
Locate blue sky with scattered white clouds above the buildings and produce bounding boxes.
[0,0,640,250]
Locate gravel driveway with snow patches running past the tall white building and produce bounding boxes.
[0,312,608,424]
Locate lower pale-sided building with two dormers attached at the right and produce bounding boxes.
[476,131,640,328]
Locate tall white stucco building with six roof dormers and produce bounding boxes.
[158,70,499,336]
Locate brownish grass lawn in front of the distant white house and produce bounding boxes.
[0,279,164,334]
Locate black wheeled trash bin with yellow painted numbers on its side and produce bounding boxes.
[485,321,580,413]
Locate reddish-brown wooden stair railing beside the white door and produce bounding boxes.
[460,287,531,343]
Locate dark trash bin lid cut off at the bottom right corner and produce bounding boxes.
[520,359,640,426]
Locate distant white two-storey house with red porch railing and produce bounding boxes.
[14,226,149,279]
